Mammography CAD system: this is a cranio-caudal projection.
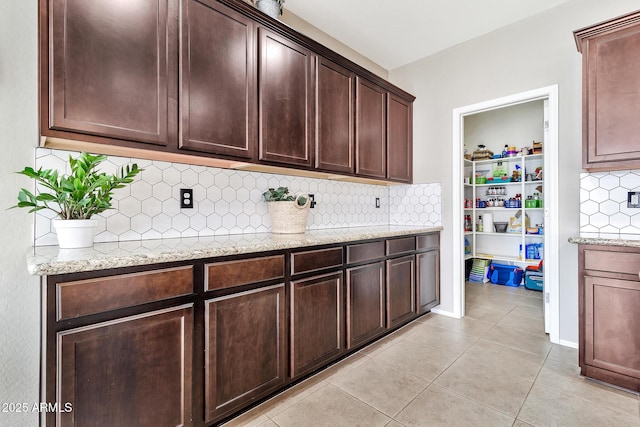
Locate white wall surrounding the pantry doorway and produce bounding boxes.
[390,0,638,343]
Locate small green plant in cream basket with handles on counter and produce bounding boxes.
[262,187,310,234]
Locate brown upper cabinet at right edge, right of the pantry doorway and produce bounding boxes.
[574,11,640,171]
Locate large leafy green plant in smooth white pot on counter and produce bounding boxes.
[12,153,142,249]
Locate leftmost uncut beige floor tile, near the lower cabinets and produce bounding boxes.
[327,359,429,417]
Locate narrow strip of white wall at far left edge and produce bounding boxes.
[0,0,40,426]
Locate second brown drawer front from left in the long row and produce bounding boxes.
[204,255,284,291]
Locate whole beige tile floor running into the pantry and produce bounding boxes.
[225,283,640,427]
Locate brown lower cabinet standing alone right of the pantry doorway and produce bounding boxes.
[579,245,640,391]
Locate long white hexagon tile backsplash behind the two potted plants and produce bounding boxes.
[35,148,441,246]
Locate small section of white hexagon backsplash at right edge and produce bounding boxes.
[580,170,640,234]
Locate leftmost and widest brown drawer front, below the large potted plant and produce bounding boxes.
[55,265,193,320]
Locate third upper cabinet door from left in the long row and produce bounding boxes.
[258,28,315,167]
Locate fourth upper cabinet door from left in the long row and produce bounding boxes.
[316,58,355,173]
